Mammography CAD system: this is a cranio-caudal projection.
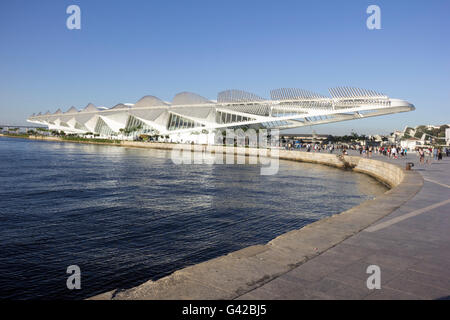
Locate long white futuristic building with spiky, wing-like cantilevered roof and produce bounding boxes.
[27,87,415,137]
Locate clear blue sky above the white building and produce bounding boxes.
[0,0,450,134]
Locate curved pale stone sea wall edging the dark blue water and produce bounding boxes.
[91,142,423,300]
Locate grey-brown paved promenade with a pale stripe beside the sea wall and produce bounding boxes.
[238,153,450,299]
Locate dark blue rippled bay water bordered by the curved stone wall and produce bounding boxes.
[0,137,386,299]
